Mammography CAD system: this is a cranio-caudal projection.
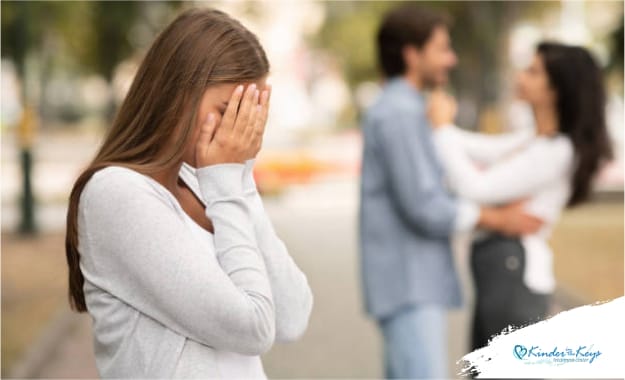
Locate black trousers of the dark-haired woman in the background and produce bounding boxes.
[471,234,551,378]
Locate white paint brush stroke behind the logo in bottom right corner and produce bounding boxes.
[458,297,625,378]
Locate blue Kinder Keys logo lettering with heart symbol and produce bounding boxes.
[512,344,602,365]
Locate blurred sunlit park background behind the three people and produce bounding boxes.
[0,0,623,377]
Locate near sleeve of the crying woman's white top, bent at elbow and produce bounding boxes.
[80,163,276,355]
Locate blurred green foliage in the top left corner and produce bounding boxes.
[2,1,184,80]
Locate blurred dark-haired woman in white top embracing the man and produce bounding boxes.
[429,42,612,350]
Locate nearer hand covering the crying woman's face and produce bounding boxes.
[195,83,270,167]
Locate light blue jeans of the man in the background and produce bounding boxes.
[379,304,447,379]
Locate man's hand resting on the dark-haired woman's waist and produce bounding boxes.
[479,200,543,236]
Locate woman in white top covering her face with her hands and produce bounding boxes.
[66,9,313,378]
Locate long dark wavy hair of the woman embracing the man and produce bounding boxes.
[537,42,612,207]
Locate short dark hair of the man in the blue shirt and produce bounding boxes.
[377,4,449,78]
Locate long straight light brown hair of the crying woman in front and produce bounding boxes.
[65,8,269,312]
